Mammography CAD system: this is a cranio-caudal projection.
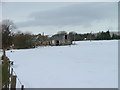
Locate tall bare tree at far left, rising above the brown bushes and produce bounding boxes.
[0,20,15,55]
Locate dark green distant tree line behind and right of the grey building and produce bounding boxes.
[56,30,120,41]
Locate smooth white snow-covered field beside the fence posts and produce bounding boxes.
[7,40,118,88]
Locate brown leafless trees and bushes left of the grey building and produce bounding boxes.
[0,20,48,49]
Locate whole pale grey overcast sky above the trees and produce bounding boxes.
[2,2,118,35]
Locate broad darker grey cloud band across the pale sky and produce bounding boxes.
[17,2,117,27]
